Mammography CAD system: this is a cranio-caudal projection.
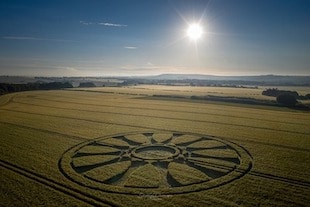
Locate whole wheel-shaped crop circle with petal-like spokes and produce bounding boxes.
[59,132,252,195]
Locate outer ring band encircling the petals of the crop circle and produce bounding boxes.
[58,131,252,195]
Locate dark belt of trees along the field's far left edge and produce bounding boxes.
[0,82,73,95]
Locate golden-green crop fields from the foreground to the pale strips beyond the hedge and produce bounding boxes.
[0,86,310,207]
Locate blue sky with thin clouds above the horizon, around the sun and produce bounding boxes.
[0,0,310,76]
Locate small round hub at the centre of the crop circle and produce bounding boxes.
[132,145,179,160]
